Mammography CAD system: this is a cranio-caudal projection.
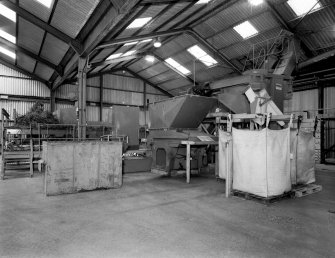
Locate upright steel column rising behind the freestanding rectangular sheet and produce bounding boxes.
[78,57,86,140]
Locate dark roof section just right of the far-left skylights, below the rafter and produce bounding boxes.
[17,18,44,54]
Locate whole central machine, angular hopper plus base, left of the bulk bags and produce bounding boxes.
[148,94,217,175]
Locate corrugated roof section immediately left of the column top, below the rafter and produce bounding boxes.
[41,33,69,65]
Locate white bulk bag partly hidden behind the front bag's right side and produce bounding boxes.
[291,129,315,184]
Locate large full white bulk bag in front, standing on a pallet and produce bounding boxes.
[232,128,291,197]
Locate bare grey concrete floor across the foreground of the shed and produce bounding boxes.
[0,168,335,258]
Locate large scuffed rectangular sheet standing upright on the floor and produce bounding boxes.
[43,142,122,196]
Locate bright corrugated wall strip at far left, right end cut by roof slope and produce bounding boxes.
[0,76,50,97]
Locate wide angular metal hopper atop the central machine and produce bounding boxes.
[149,95,217,129]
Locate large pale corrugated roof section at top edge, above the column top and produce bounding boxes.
[51,0,99,38]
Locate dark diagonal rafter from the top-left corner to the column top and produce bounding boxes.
[0,0,81,52]
